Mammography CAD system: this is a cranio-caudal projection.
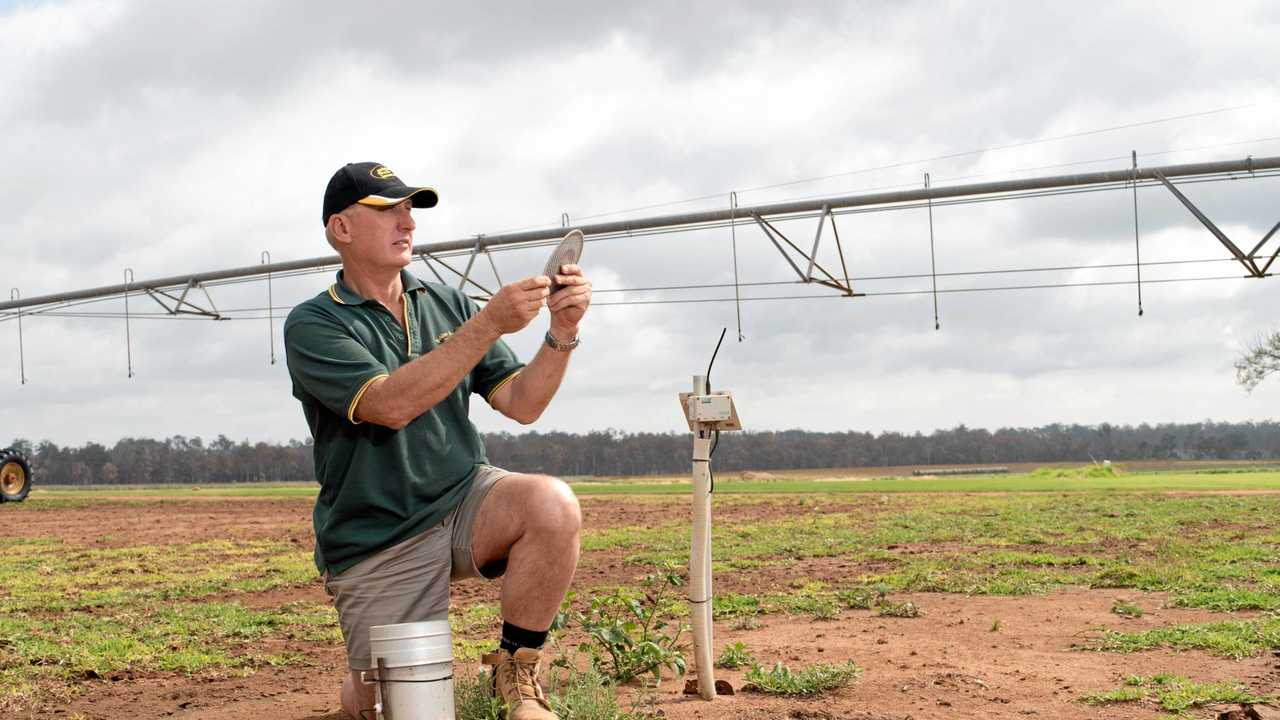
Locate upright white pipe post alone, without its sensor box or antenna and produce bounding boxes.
[689,375,716,700]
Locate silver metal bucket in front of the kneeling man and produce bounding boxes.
[369,620,453,720]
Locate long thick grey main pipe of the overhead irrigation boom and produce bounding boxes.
[0,156,1280,310]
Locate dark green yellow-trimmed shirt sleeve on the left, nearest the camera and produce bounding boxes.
[284,307,390,424]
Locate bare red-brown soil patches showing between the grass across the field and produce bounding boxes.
[0,484,1280,720]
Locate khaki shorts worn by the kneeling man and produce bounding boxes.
[324,465,511,670]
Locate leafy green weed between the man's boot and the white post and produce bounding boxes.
[572,565,687,684]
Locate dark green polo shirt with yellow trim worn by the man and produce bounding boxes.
[284,270,524,575]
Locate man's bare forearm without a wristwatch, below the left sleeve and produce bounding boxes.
[356,315,502,429]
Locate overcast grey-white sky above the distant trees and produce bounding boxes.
[0,0,1280,445]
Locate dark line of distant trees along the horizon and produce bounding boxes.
[10,421,1280,486]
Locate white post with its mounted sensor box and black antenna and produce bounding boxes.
[680,333,742,700]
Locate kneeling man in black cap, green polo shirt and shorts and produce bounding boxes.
[284,163,591,720]
